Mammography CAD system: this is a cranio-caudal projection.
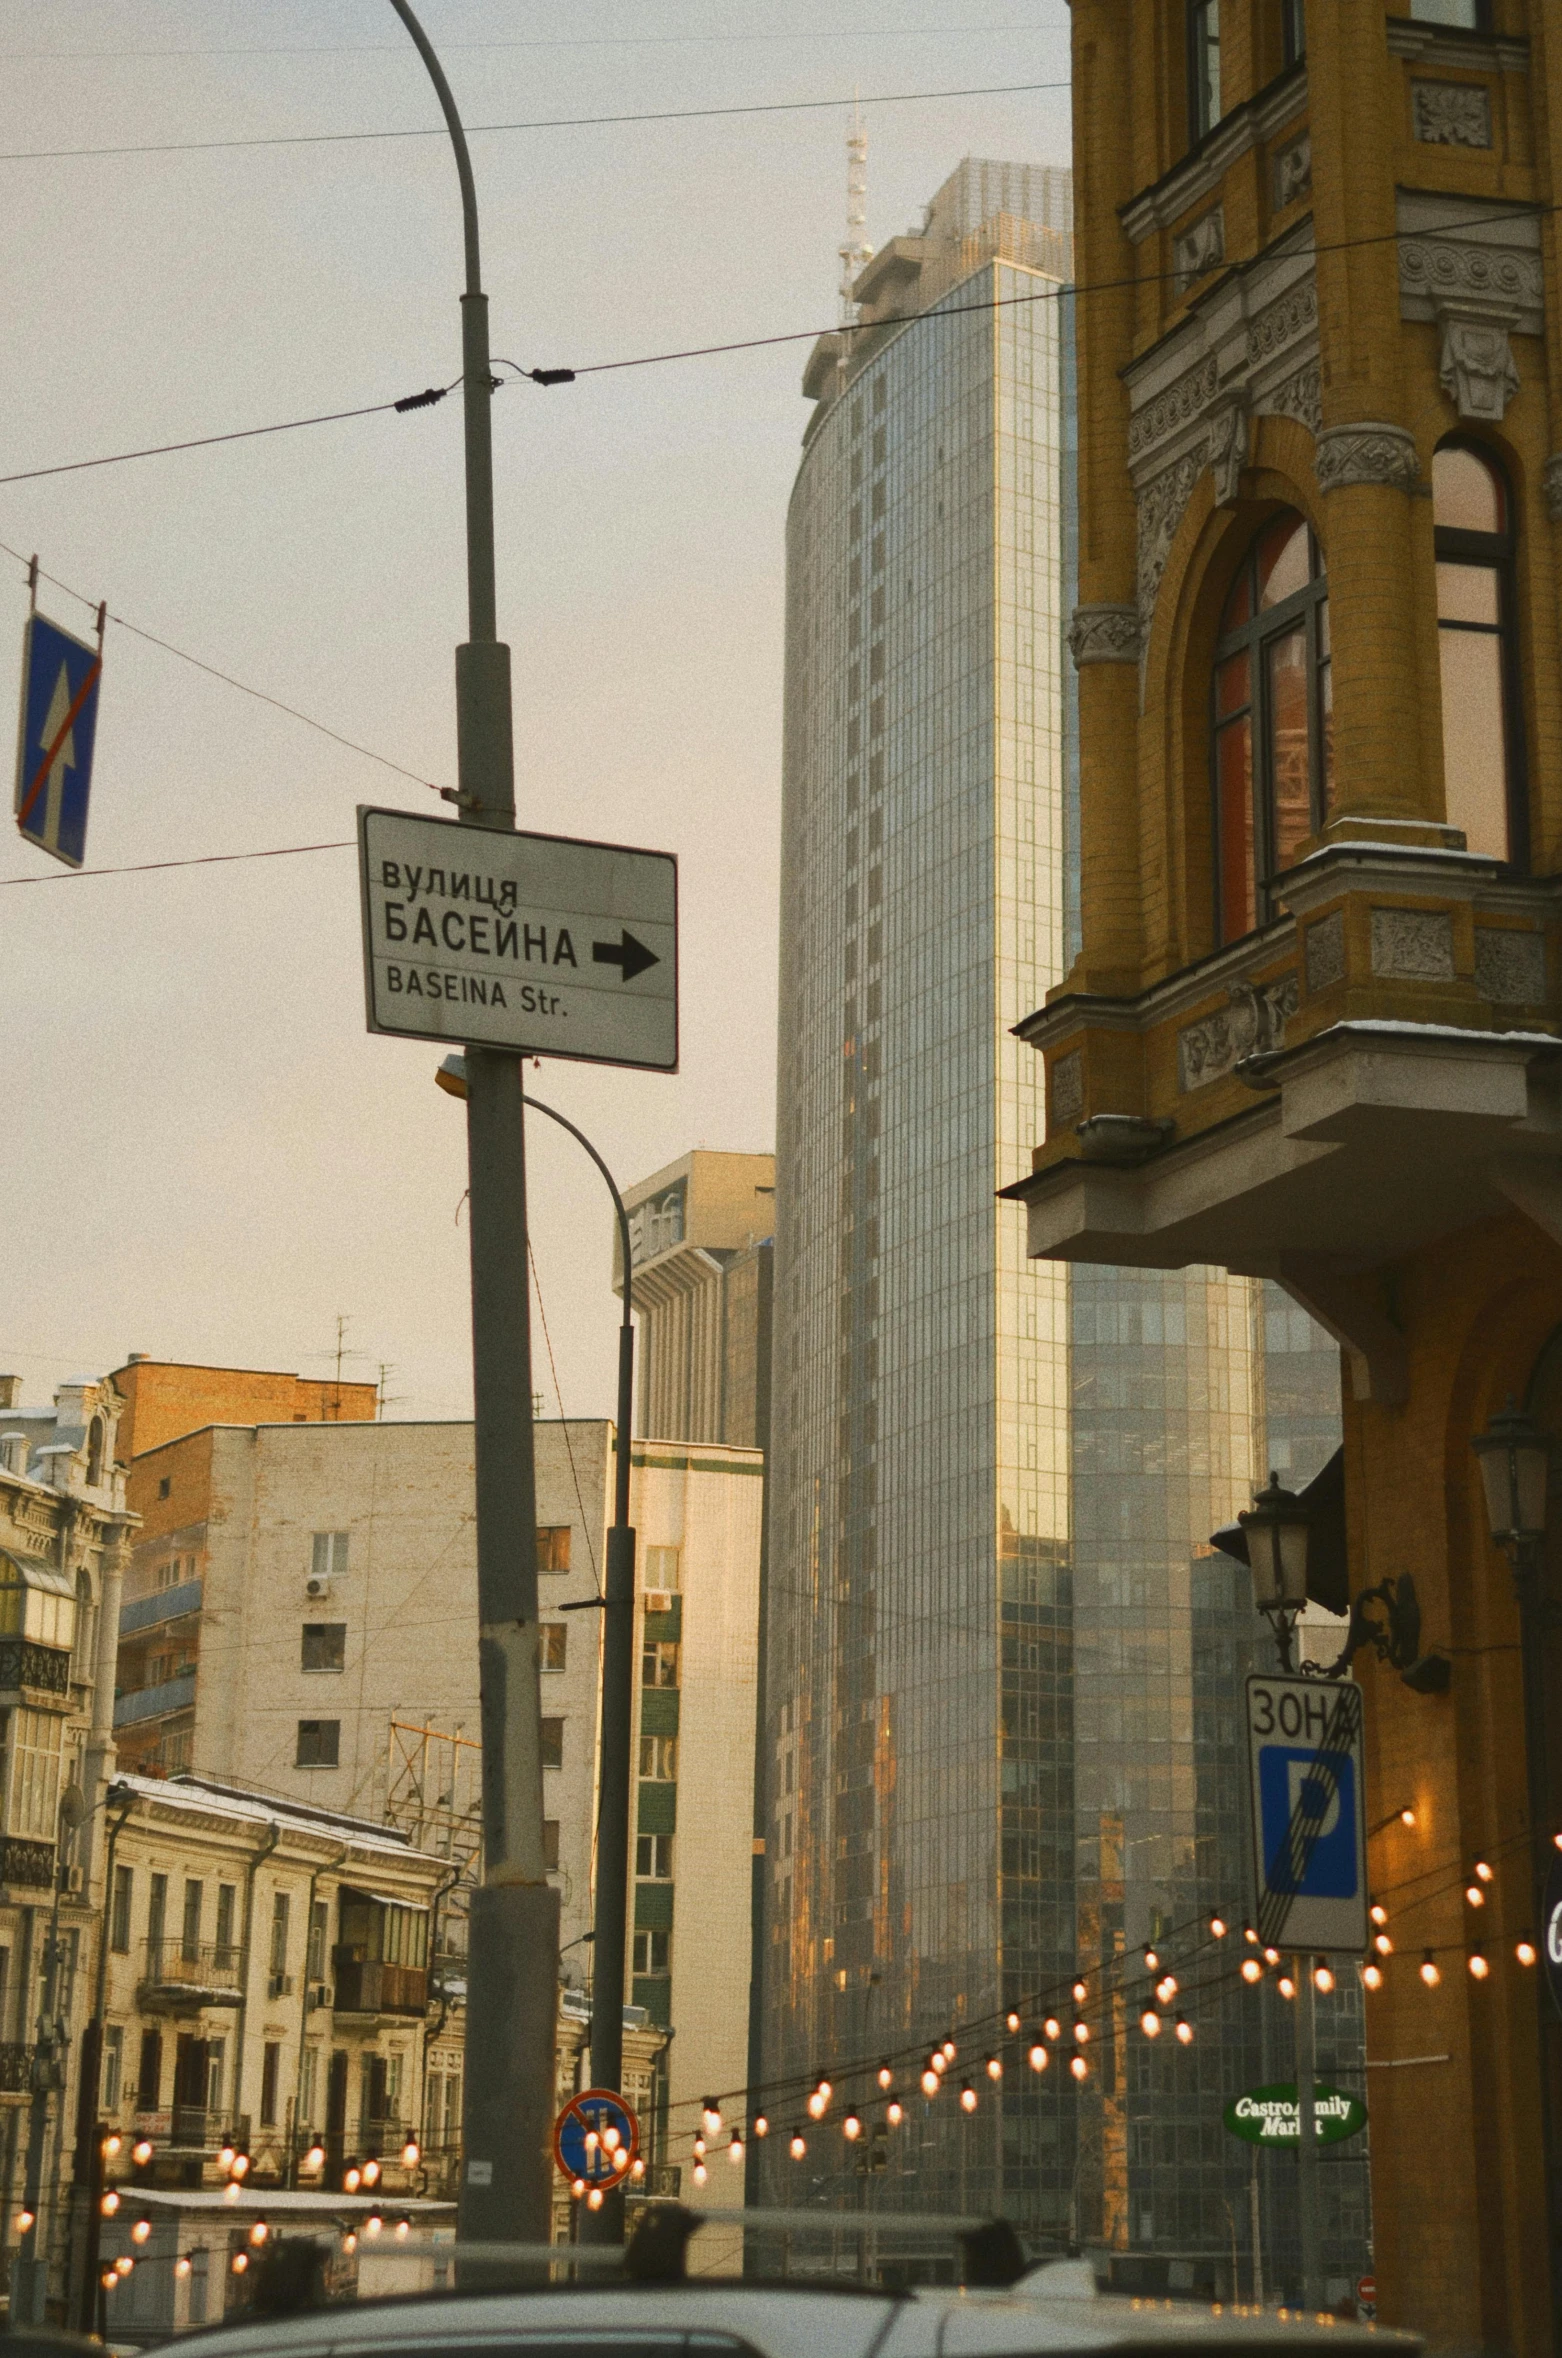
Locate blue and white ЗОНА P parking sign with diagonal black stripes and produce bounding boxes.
[1248,1674,1366,1952]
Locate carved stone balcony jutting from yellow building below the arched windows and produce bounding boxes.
[1005,842,1562,1401]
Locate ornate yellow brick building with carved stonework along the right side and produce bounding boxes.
[1015,0,1562,2353]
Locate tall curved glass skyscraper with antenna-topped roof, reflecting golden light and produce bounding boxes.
[764,160,1364,2290]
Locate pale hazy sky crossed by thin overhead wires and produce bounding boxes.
[0,0,1069,1417]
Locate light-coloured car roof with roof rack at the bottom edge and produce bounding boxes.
[155,2261,1420,2358]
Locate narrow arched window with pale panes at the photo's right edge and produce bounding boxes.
[1432,441,1524,861]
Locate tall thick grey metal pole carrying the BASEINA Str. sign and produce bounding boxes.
[392,0,559,2242]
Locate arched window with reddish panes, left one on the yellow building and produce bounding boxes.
[1215,509,1333,941]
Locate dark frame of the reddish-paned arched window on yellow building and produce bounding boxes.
[1208,507,1333,950]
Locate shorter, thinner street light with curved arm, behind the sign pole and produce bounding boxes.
[434,1049,635,2242]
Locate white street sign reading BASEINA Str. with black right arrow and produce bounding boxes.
[359,806,677,1073]
